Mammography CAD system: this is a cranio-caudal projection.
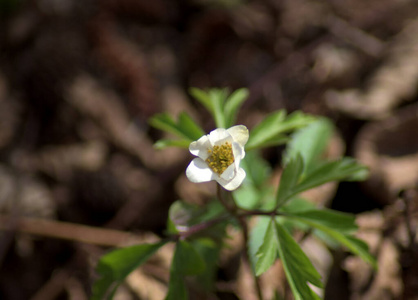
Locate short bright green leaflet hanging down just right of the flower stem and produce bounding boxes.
[255,218,278,276]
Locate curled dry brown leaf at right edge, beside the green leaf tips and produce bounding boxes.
[355,104,418,204]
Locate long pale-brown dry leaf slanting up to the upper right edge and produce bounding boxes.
[326,19,418,119]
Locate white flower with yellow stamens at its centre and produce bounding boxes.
[186,125,248,191]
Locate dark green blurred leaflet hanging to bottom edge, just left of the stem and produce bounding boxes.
[165,241,205,300]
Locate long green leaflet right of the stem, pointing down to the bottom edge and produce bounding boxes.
[275,222,322,300]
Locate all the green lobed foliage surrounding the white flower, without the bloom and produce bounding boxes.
[92,88,376,300]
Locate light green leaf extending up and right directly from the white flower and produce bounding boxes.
[245,110,315,151]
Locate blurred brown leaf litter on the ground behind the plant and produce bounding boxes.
[0,0,418,300]
